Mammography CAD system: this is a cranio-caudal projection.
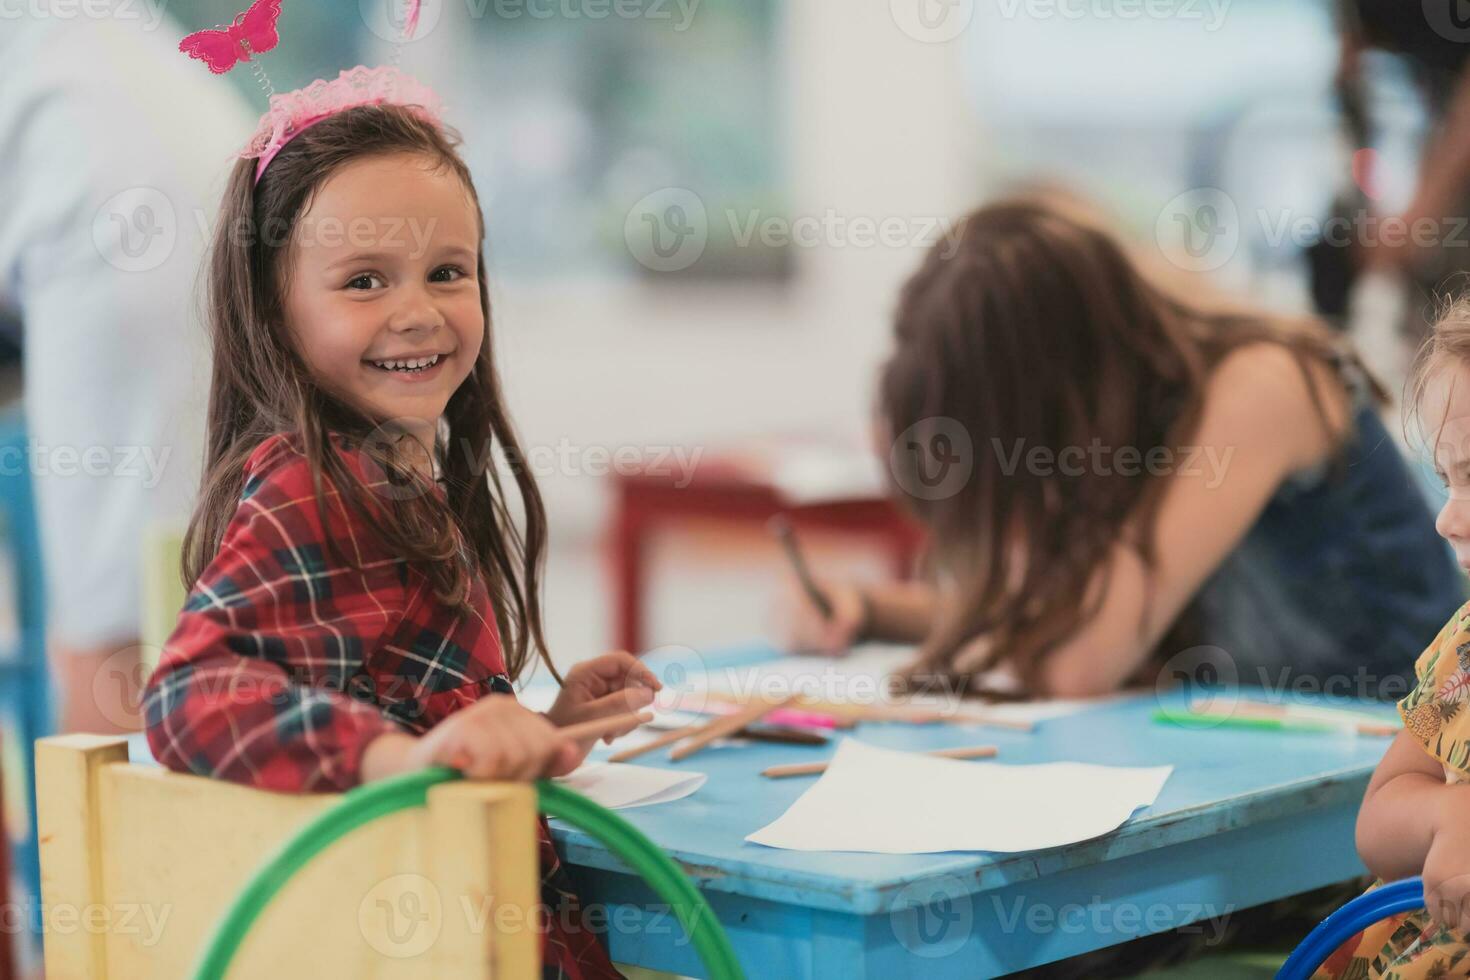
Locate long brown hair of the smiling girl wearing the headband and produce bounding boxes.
[181,106,560,680]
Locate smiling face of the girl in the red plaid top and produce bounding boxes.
[285,154,485,447]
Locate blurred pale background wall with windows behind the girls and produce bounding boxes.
[160,0,1424,655]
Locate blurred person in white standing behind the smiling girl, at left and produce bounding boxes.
[0,0,256,733]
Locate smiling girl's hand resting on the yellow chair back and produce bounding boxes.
[408,693,591,782]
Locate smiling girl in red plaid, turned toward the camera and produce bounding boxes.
[144,69,649,977]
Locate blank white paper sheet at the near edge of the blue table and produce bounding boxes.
[745,739,1173,854]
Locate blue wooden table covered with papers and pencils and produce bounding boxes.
[553,648,1397,980]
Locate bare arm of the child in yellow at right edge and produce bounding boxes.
[1357,732,1470,882]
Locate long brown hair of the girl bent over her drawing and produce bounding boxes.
[879,198,1382,691]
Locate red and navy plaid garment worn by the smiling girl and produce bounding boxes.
[144,435,622,980]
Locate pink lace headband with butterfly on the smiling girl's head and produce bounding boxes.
[179,0,444,184]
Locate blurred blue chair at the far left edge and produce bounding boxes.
[0,410,54,934]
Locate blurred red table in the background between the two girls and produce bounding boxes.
[607,458,923,652]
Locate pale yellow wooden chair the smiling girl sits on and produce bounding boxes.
[35,735,539,980]
